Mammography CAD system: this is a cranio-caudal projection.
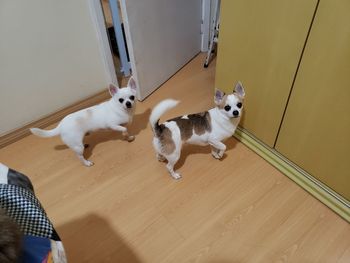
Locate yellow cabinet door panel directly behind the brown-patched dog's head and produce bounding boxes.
[215,0,317,146]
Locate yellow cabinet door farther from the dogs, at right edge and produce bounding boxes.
[276,0,350,200]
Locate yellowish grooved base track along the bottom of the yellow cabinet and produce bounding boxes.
[234,128,350,222]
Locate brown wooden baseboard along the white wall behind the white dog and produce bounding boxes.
[0,90,110,148]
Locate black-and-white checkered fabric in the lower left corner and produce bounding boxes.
[0,184,57,239]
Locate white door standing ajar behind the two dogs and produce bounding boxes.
[121,0,202,100]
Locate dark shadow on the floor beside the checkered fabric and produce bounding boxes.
[57,214,141,263]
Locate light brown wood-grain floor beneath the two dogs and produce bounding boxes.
[0,55,350,263]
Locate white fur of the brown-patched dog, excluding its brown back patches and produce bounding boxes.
[149,82,245,179]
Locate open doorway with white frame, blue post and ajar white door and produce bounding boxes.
[89,0,203,101]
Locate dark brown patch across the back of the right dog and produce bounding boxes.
[169,111,211,141]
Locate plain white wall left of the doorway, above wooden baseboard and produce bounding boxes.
[0,0,108,135]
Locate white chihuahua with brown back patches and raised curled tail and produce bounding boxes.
[150,82,245,179]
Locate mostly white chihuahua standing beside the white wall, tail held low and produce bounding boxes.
[30,77,136,166]
